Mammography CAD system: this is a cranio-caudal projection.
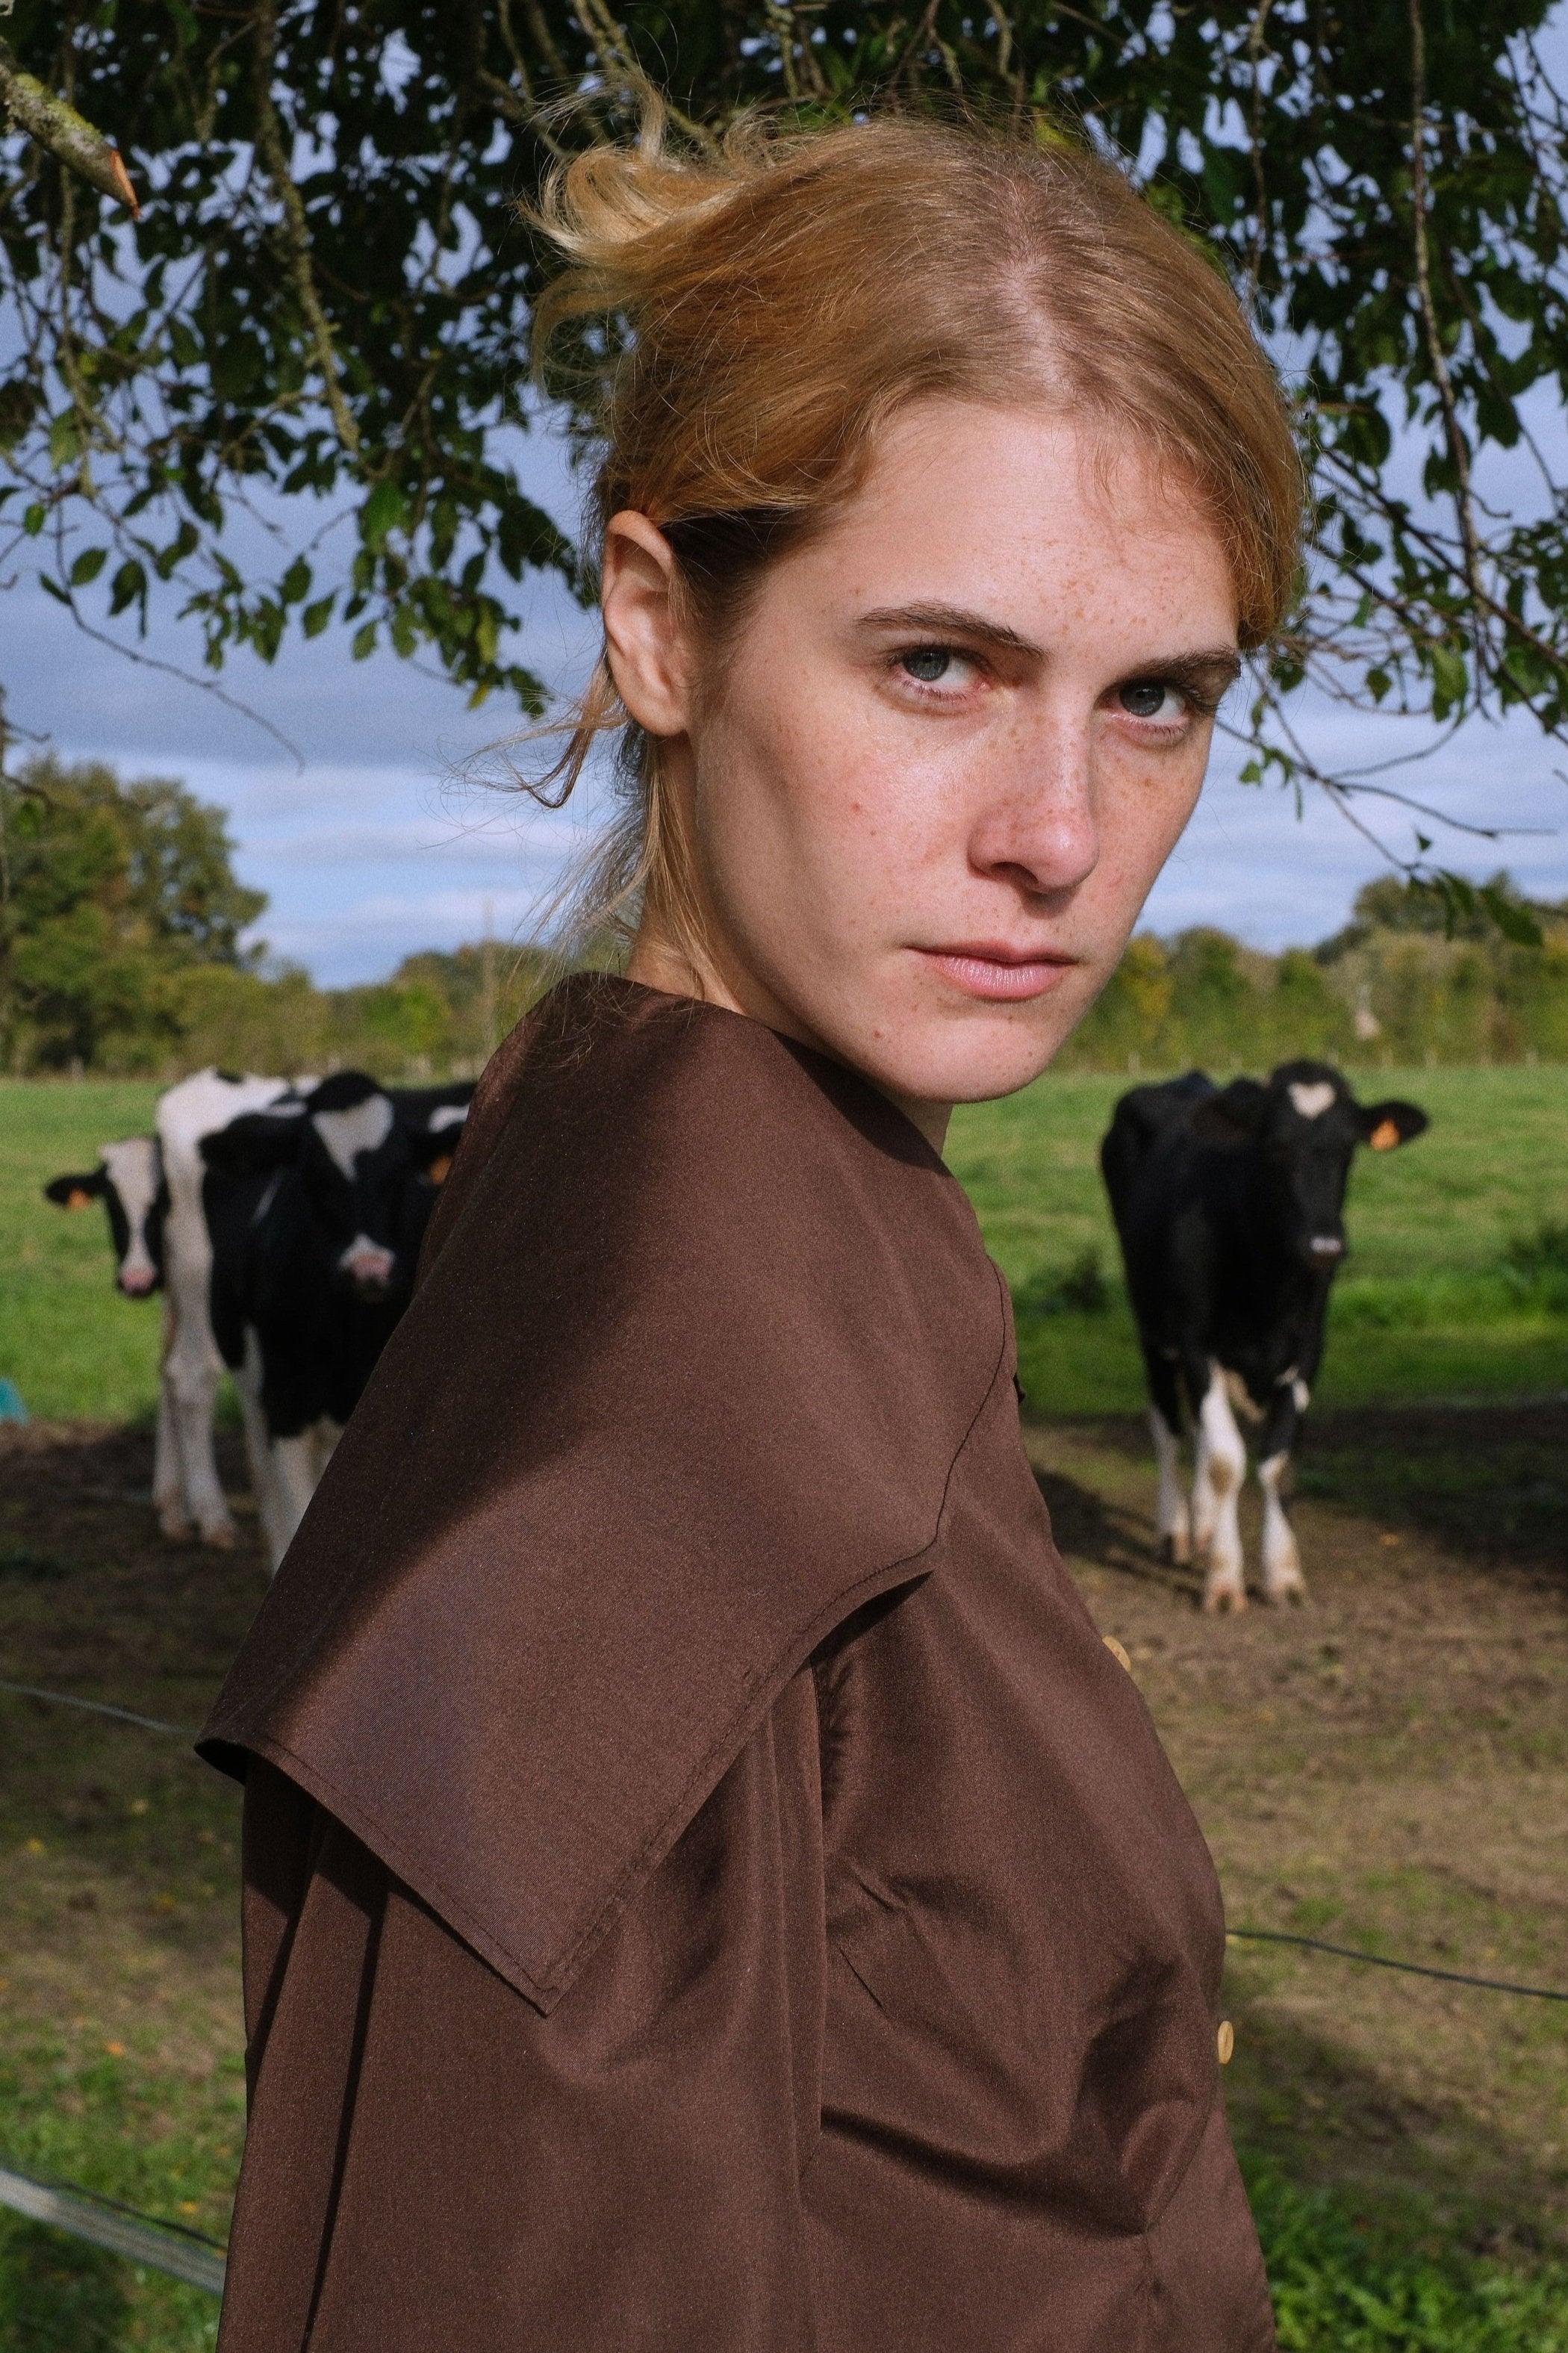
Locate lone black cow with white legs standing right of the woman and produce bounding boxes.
[1100,1061,1427,1609]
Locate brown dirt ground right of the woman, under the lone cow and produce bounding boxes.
[1029,1405,1568,2247]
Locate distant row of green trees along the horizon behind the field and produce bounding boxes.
[0,760,1568,1078]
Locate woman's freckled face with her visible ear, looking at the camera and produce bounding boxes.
[603,402,1239,1139]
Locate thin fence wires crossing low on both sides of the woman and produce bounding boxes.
[0,1678,1568,2296]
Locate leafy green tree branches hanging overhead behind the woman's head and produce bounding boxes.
[0,0,1568,884]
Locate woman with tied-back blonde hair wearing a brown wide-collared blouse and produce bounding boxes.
[205,105,1300,2353]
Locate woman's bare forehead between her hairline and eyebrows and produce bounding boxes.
[800,400,1236,644]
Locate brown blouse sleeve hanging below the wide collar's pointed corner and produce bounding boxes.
[219,1676,821,2353]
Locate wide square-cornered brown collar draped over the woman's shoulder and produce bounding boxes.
[200,975,1012,2014]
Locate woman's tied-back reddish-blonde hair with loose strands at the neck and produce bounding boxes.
[515,99,1302,955]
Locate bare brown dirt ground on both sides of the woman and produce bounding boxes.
[0,1405,1568,2252]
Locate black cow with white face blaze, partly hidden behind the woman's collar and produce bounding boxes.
[202,1071,473,1567]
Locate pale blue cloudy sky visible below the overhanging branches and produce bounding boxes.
[15,400,1568,986]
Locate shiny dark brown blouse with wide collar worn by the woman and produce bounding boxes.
[202,979,1274,2353]
